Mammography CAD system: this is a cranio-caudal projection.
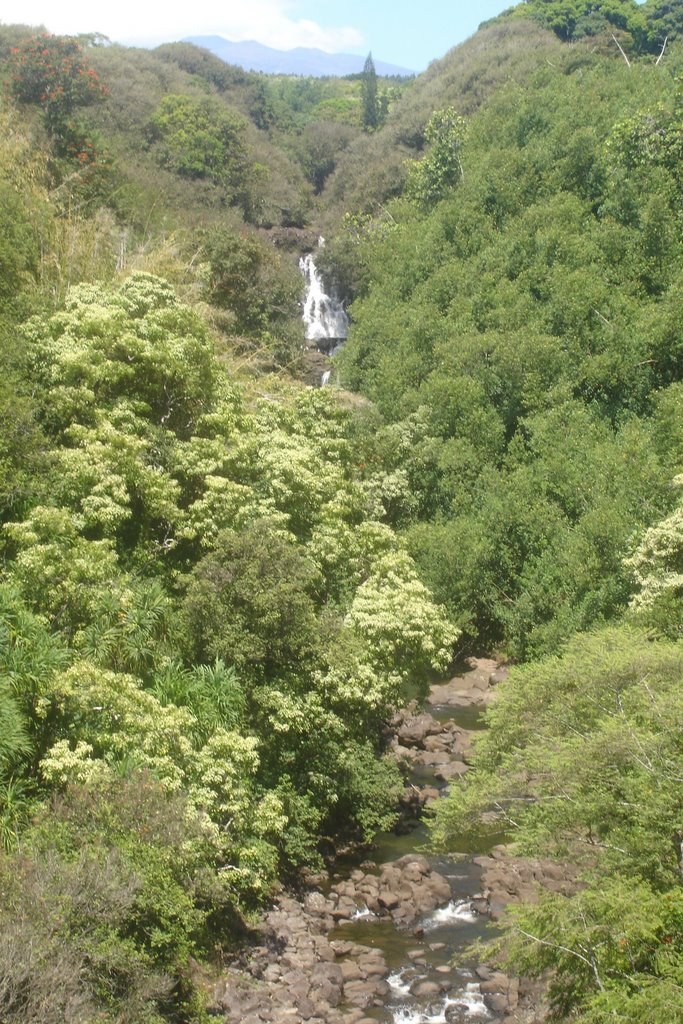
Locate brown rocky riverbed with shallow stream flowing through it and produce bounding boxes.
[211,659,574,1024]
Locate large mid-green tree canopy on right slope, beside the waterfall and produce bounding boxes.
[338,36,683,656]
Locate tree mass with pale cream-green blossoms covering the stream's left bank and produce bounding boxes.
[0,258,455,1021]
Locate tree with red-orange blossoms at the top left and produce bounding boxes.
[11,35,108,132]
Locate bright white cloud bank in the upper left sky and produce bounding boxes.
[2,0,365,53]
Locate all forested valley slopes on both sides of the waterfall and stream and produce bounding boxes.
[0,0,683,1024]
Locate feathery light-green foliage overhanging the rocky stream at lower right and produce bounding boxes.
[434,628,683,1024]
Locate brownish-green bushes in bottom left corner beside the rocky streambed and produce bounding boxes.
[0,776,234,1024]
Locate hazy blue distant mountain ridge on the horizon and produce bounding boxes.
[183,36,417,78]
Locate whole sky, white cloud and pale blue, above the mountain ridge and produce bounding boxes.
[0,0,520,71]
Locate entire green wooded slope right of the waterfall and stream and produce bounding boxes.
[321,4,683,1022]
